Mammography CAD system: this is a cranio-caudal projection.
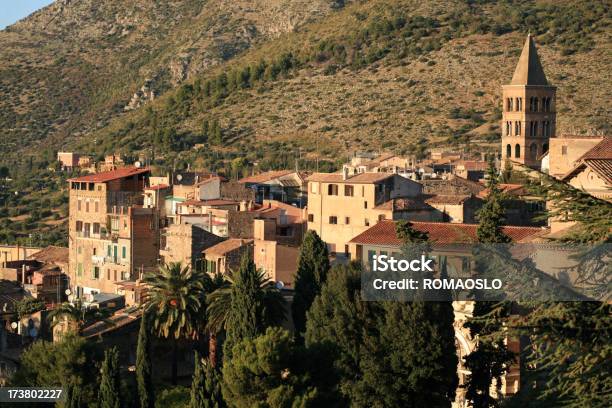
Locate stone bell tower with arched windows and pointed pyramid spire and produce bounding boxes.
[501,34,557,169]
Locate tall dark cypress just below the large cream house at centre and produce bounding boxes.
[291,231,329,335]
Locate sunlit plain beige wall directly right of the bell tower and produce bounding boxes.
[548,137,602,178]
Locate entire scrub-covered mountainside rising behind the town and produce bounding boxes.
[0,0,611,164]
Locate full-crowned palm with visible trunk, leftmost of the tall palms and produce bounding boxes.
[143,262,210,385]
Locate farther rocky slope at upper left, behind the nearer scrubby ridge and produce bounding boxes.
[0,0,346,159]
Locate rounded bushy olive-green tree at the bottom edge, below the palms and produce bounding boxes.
[223,327,337,408]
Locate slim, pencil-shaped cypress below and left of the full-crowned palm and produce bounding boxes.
[136,313,155,408]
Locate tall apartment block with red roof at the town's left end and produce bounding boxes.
[68,168,159,298]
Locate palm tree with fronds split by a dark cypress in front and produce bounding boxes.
[206,257,286,366]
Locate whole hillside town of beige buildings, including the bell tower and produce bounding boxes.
[0,36,612,407]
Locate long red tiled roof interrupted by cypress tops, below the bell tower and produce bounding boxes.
[350,220,546,246]
